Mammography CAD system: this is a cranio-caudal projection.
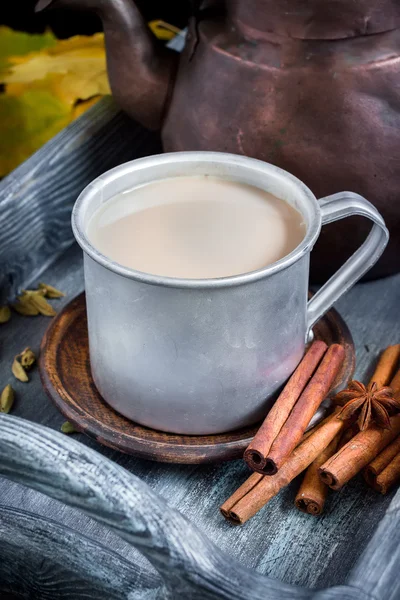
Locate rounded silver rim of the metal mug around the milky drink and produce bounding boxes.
[71,151,321,289]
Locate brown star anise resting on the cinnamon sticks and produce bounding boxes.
[334,381,400,431]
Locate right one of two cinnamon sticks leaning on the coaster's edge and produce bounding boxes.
[245,344,345,475]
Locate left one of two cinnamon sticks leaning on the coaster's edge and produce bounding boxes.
[244,340,328,472]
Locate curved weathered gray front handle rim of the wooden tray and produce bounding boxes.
[0,415,394,600]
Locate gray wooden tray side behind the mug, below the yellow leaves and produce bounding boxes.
[0,97,161,304]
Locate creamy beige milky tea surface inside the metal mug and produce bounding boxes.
[87,175,306,279]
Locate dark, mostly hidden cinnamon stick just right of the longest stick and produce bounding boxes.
[294,430,349,516]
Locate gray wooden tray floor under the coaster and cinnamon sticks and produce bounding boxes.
[0,246,400,587]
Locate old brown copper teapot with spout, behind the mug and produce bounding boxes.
[37,0,400,281]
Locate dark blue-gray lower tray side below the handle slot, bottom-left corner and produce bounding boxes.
[0,506,159,600]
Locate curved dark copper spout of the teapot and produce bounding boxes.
[35,0,178,130]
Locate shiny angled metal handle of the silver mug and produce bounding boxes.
[307,192,389,332]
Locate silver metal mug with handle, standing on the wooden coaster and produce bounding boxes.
[72,152,389,434]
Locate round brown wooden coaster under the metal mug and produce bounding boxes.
[40,294,355,464]
